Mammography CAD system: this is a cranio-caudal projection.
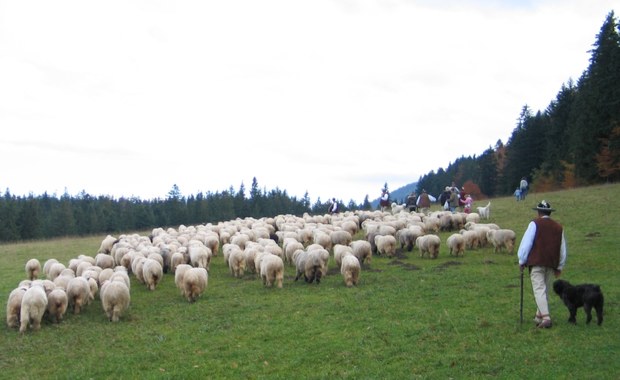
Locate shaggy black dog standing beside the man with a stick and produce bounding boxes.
[553,280,603,326]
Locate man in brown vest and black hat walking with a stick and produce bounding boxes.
[517,201,566,328]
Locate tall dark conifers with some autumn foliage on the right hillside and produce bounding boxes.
[418,11,620,198]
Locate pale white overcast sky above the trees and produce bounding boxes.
[0,0,620,203]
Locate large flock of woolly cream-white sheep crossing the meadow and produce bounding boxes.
[6,205,515,333]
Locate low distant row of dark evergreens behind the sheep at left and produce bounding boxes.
[0,178,371,242]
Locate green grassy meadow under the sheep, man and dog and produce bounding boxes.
[0,184,620,379]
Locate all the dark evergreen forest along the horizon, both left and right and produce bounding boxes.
[0,11,620,242]
